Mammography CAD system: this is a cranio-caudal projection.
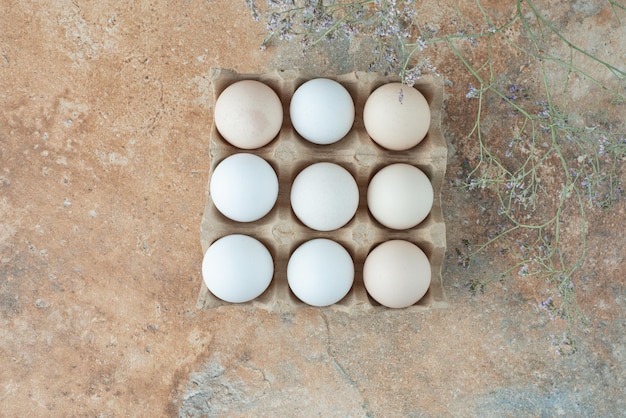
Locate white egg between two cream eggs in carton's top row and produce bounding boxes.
[289,78,354,145]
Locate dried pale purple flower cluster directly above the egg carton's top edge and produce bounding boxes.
[245,0,437,86]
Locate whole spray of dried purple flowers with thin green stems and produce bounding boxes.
[245,0,626,355]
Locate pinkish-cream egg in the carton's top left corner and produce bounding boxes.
[214,80,283,149]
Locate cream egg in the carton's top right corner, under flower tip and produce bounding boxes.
[363,83,430,151]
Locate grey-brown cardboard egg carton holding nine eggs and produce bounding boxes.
[197,68,447,312]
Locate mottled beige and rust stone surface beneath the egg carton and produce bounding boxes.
[0,0,626,417]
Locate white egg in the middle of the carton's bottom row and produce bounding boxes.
[287,238,354,306]
